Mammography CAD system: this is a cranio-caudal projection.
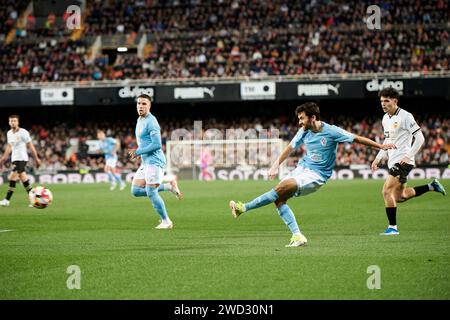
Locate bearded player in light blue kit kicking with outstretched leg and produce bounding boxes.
[229,102,394,247]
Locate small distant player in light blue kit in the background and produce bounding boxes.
[97,130,126,191]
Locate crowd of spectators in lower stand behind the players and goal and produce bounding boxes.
[0,116,450,172]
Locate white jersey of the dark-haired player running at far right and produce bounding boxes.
[383,108,420,168]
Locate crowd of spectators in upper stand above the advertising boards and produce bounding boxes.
[0,0,450,83]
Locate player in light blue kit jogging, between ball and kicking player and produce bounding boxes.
[128,94,182,229]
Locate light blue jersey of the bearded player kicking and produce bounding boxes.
[290,121,355,180]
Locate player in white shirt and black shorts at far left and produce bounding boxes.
[0,115,41,207]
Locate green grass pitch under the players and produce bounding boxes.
[0,180,450,299]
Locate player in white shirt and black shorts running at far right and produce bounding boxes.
[372,87,446,235]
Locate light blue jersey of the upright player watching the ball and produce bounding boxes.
[136,112,166,168]
